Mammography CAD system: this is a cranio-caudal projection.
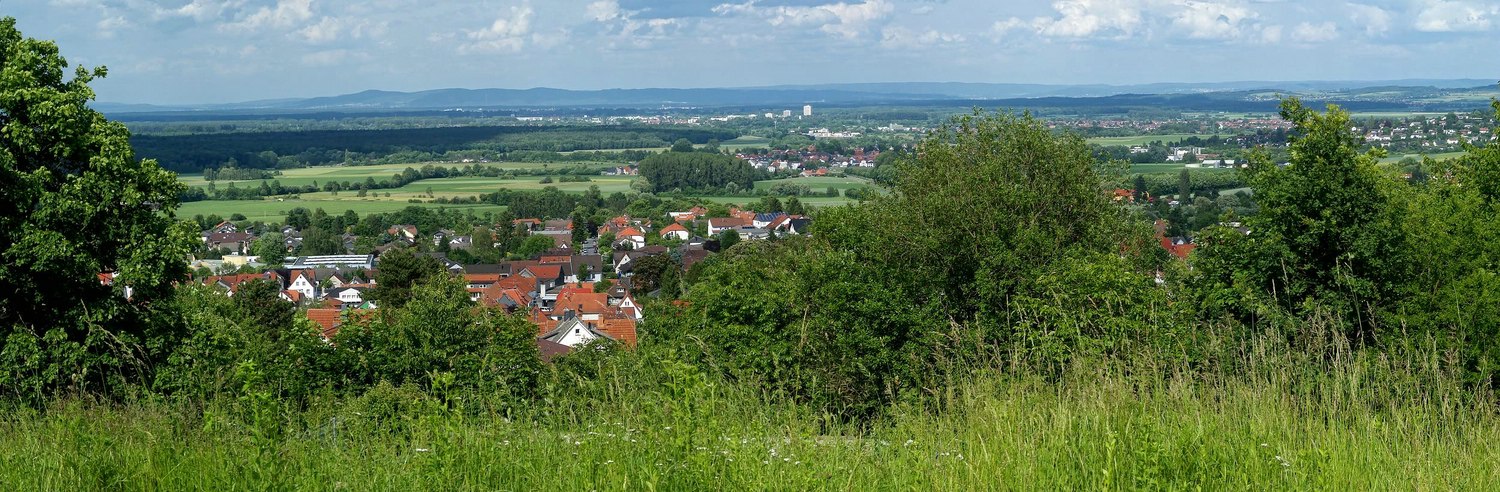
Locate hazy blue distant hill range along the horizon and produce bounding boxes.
[95,80,1500,114]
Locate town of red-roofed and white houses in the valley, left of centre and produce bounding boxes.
[193,207,812,359]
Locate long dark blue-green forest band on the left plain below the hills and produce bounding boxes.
[131,125,738,173]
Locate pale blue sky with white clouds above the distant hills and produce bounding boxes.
[11,0,1500,104]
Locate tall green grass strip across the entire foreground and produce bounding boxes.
[0,327,1500,491]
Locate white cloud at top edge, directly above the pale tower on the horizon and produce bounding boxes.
[713,0,896,39]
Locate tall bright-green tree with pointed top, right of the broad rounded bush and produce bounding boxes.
[1196,99,1412,327]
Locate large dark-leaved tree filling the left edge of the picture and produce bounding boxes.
[0,18,195,398]
